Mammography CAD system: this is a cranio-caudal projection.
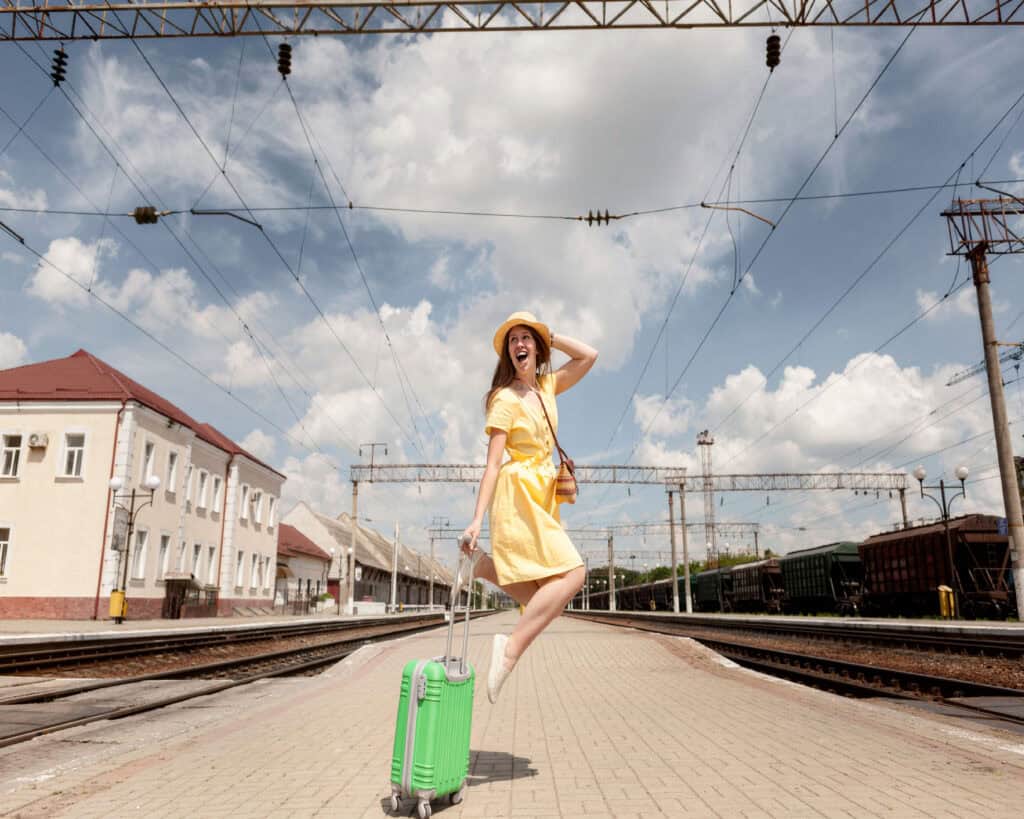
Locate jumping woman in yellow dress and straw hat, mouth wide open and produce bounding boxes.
[456,312,597,702]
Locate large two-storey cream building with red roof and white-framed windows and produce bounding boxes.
[0,350,285,619]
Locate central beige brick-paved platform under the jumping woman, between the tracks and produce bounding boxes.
[0,612,1024,819]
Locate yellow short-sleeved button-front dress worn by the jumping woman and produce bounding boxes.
[484,375,583,586]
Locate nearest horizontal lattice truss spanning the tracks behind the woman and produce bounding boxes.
[349,464,905,492]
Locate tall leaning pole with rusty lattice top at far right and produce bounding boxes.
[942,197,1024,620]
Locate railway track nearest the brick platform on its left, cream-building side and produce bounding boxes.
[0,612,492,747]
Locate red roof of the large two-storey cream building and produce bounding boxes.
[0,350,285,477]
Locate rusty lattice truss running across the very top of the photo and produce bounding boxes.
[0,0,1024,41]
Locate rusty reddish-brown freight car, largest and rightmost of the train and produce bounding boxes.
[859,515,1014,618]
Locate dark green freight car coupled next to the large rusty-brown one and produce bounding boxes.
[779,542,864,614]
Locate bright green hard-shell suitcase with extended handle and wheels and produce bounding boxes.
[391,552,476,819]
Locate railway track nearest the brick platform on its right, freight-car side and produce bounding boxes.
[570,612,1024,726]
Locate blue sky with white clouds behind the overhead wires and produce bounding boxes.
[0,29,1024,569]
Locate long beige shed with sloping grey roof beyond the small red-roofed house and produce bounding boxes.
[284,503,453,612]
